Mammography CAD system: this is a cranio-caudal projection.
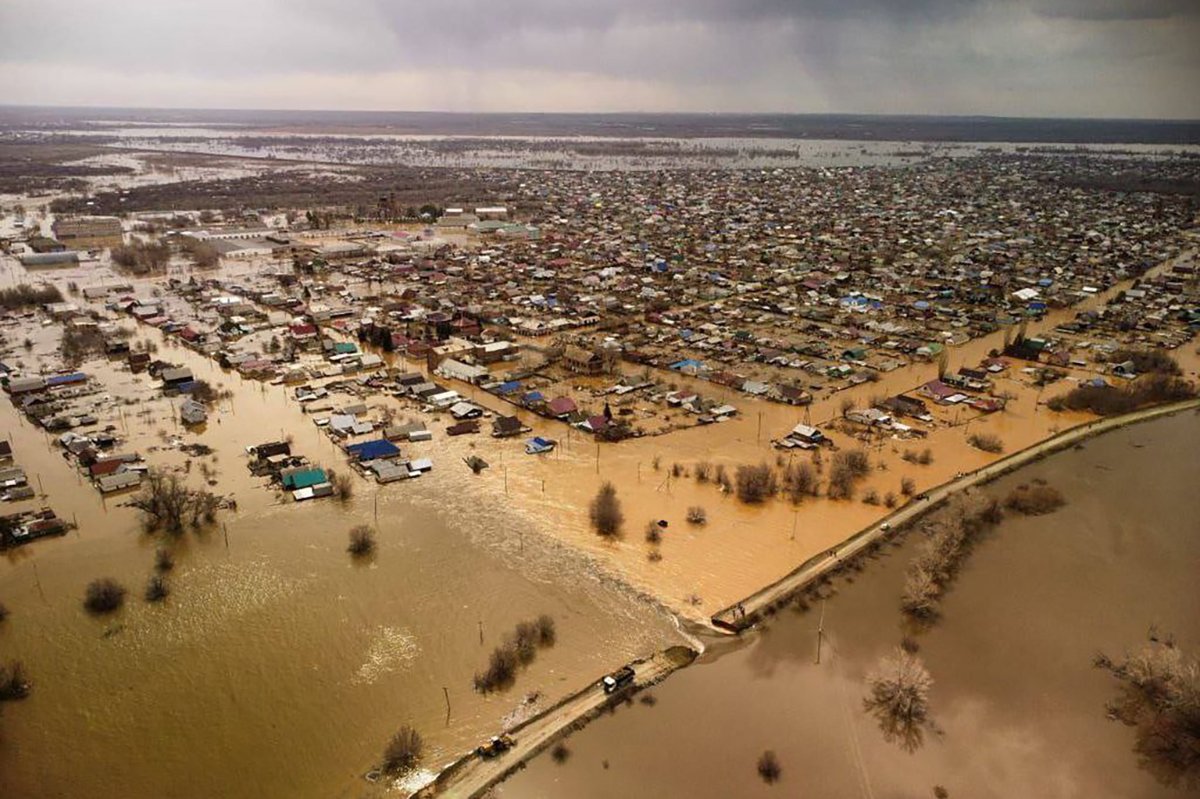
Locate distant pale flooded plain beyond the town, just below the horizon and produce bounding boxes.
[23,125,1200,172]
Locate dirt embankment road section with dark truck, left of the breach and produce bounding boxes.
[414,647,696,799]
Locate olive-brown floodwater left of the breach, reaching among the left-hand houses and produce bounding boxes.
[0,295,680,798]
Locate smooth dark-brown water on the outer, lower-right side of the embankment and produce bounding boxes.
[498,413,1200,799]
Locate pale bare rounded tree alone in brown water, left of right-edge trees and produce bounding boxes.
[863,647,934,752]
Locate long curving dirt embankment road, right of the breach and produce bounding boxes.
[713,400,1200,632]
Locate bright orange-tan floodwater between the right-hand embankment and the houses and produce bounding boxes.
[4,245,1200,638]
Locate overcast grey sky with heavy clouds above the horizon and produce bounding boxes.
[0,0,1200,119]
